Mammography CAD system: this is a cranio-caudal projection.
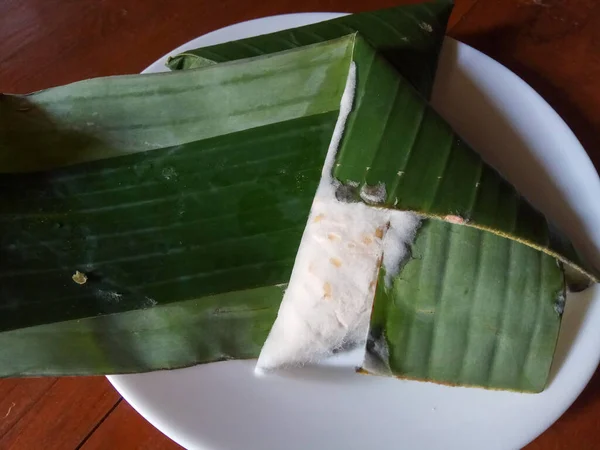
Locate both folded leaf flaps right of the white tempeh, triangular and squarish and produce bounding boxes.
[334,36,596,392]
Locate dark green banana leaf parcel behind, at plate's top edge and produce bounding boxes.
[167,0,453,97]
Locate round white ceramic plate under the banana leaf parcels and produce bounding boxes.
[109,14,600,450]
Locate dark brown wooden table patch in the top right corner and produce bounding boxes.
[450,0,600,170]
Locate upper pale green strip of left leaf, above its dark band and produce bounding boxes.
[0,38,352,173]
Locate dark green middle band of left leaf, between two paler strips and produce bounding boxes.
[0,113,336,330]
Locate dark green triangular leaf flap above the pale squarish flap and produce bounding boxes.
[334,36,594,278]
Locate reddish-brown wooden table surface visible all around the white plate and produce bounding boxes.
[0,0,600,450]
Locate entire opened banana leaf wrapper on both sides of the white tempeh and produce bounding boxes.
[0,0,596,391]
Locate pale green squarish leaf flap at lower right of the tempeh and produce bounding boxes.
[365,219,565,392]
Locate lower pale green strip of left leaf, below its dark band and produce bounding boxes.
[0,286,283,376]
